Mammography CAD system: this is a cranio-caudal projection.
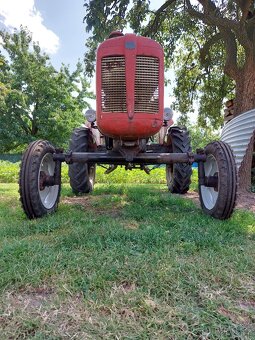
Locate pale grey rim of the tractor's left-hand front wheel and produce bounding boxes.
[38,153,59,209]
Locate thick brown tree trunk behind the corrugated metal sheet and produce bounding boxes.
[234,58,255,193]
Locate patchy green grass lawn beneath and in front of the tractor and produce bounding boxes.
[0,175,255,339]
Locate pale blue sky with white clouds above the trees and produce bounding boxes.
[0,0,175,110]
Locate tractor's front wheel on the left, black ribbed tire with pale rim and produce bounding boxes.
[19,140,60,219]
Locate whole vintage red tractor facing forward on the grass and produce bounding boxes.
[19,32,236,219]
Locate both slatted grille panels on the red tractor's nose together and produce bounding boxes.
[101,56,159,113]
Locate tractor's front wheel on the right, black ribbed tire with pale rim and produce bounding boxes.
[199,141,237,220]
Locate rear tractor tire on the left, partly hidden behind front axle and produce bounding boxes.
[68,127,96,195]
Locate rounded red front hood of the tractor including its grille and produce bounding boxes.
[96,32,164,141]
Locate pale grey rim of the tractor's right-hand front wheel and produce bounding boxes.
[200,155,219,210]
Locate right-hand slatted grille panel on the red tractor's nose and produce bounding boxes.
[135,56,159,113]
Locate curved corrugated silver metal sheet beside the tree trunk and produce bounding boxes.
[220,109,255,171]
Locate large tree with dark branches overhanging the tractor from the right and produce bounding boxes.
[84,0,255,128]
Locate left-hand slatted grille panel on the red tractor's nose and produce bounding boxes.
[101,56,127,112]
